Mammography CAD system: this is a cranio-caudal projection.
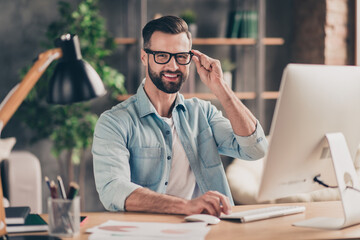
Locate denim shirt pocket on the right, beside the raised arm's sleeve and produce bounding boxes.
[196,127,221,168]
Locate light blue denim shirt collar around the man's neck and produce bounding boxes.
[136,79,186,118]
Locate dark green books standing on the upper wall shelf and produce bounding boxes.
[227,10,258,38]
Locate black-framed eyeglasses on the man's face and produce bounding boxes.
[144,48,194,65]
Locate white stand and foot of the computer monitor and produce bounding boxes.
[293,133,360,229]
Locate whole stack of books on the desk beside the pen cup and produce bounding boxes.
[5,207,48,233]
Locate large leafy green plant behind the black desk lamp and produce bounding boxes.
[16,0,126,207]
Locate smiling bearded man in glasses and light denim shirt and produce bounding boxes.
[92,16,267,216]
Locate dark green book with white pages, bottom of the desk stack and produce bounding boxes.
[6,213,48,233]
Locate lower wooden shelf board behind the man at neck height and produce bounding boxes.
[117,92,279,102]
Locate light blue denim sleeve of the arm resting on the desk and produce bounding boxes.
[92,113,141,211]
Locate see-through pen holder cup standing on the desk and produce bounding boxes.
[48,197,80,237]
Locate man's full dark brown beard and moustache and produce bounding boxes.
[148,66,188,93]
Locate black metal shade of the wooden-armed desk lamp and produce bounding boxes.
[47,34,106,104]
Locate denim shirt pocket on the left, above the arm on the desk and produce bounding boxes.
[130,147,164,188]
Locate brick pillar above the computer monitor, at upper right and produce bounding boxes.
[292,0,354,65]
